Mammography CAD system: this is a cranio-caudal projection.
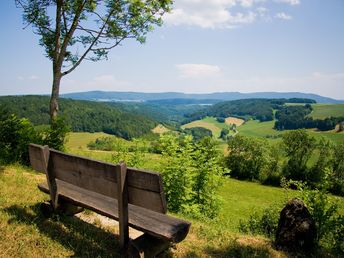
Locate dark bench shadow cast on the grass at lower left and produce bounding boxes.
[4,204,120,257]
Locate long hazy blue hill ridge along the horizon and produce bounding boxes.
[61,91,344,104]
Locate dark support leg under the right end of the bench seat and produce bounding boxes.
[128,234,170,258]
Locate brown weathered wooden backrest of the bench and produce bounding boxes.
[29,144,167,213]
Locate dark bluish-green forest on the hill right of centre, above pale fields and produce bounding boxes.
[183,98,315,123]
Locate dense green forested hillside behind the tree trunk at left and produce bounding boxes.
[0,96,157,139]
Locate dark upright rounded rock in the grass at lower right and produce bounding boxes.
[276,199,316,251]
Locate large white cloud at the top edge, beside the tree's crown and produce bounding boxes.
[164,0,301,29]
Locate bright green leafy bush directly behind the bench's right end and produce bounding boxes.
[160,134,223,218]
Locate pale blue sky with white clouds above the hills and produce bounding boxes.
[0,0,344,100]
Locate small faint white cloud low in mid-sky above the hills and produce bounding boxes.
[176,64,221,79]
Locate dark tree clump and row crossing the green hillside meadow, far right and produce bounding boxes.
[274,104,344,131]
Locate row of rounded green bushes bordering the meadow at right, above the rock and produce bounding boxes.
[226,129,344,196]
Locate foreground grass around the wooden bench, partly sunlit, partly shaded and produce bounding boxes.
[0,165,344,257]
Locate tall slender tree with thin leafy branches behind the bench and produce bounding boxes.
[15,0,172,121]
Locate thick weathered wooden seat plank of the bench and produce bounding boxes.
[39,179,191,243]
